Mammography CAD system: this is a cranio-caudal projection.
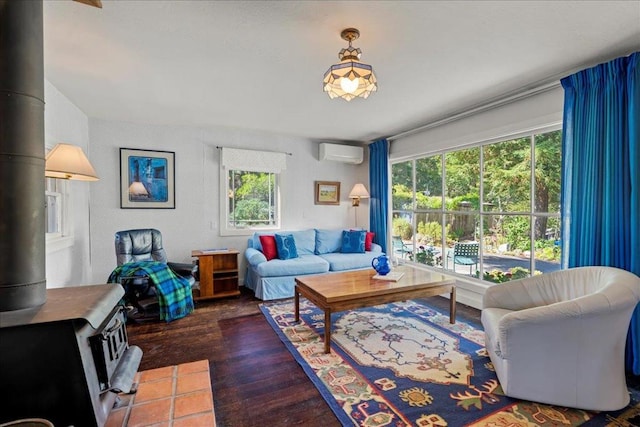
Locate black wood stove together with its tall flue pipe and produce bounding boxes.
[0,0,142,427]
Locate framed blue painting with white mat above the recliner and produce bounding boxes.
[120,148,176,209]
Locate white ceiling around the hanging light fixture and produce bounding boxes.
[44,0,640,141]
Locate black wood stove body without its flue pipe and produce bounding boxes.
[0,284,142,427]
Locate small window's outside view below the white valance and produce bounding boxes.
[227,170,277,229]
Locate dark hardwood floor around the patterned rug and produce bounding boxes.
[127,287,480,427]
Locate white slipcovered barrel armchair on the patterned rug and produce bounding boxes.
[482,267,640,411]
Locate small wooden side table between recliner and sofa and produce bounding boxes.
[191,249,240,301]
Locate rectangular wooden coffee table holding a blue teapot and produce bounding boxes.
[295,265,456,353]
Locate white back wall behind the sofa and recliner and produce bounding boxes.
[89,119,369,283]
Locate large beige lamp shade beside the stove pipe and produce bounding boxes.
[44,144,100,181]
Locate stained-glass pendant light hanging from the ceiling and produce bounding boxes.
[324,28,378,101]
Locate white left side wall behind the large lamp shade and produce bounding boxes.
[44,80,92,288]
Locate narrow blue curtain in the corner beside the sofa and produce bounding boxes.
[369,139,389,253]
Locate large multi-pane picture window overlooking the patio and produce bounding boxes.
[391,130,562,282]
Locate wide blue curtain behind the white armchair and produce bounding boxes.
[562,52,640,375]
